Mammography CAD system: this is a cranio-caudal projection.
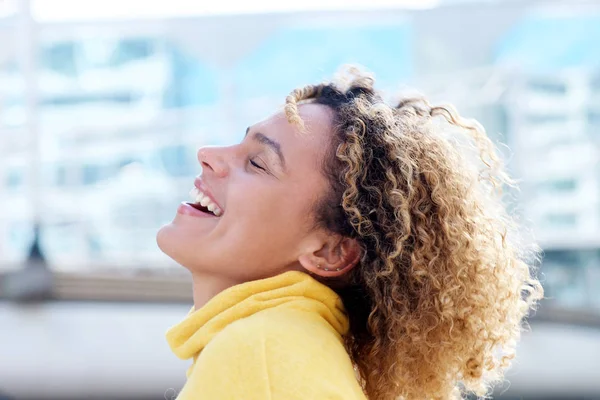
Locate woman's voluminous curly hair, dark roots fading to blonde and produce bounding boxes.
[285,68,543,400]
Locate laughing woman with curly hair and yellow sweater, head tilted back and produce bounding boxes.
[157,68,542,400]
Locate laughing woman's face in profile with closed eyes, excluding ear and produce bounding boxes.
[157,104,332,282]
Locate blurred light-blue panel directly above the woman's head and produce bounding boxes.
[234,23,413,97]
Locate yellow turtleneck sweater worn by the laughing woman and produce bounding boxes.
[167,271,366,400]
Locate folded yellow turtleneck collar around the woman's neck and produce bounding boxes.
[167,271,349,359]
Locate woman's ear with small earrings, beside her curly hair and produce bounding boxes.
[298,234,362,277]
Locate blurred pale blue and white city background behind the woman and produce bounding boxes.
[0,0,600,399]
